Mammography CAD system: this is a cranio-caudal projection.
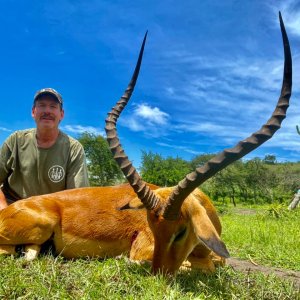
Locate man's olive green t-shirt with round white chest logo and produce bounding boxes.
[0,129,89,201]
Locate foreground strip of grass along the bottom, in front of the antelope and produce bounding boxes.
[0,256,300,299]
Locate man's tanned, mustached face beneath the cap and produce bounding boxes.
[31,95,64,129]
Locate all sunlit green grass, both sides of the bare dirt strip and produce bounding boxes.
[0,207,300,300]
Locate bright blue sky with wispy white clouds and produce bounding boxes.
[0,0,300,166]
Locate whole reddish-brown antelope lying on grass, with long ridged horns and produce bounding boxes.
[0,13,292,274]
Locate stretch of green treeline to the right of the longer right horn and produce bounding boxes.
[202,158,300,205]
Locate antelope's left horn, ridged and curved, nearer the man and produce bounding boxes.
[105,32,159,210]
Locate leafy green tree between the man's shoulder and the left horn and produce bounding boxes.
[78,132,124,186]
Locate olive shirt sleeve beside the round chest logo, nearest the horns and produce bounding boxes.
[66,141,89,189]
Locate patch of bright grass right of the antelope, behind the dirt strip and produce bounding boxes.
[221,206,300,271]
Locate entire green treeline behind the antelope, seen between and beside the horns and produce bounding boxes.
[79,133,300,205]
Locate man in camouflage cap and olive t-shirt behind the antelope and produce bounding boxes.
[0,88,89,209]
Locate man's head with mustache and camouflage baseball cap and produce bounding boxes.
[31,88,64,130]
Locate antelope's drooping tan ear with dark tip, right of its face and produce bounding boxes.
[191,204,230,258]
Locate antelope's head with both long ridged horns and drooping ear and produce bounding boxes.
[105,13,292,273]
